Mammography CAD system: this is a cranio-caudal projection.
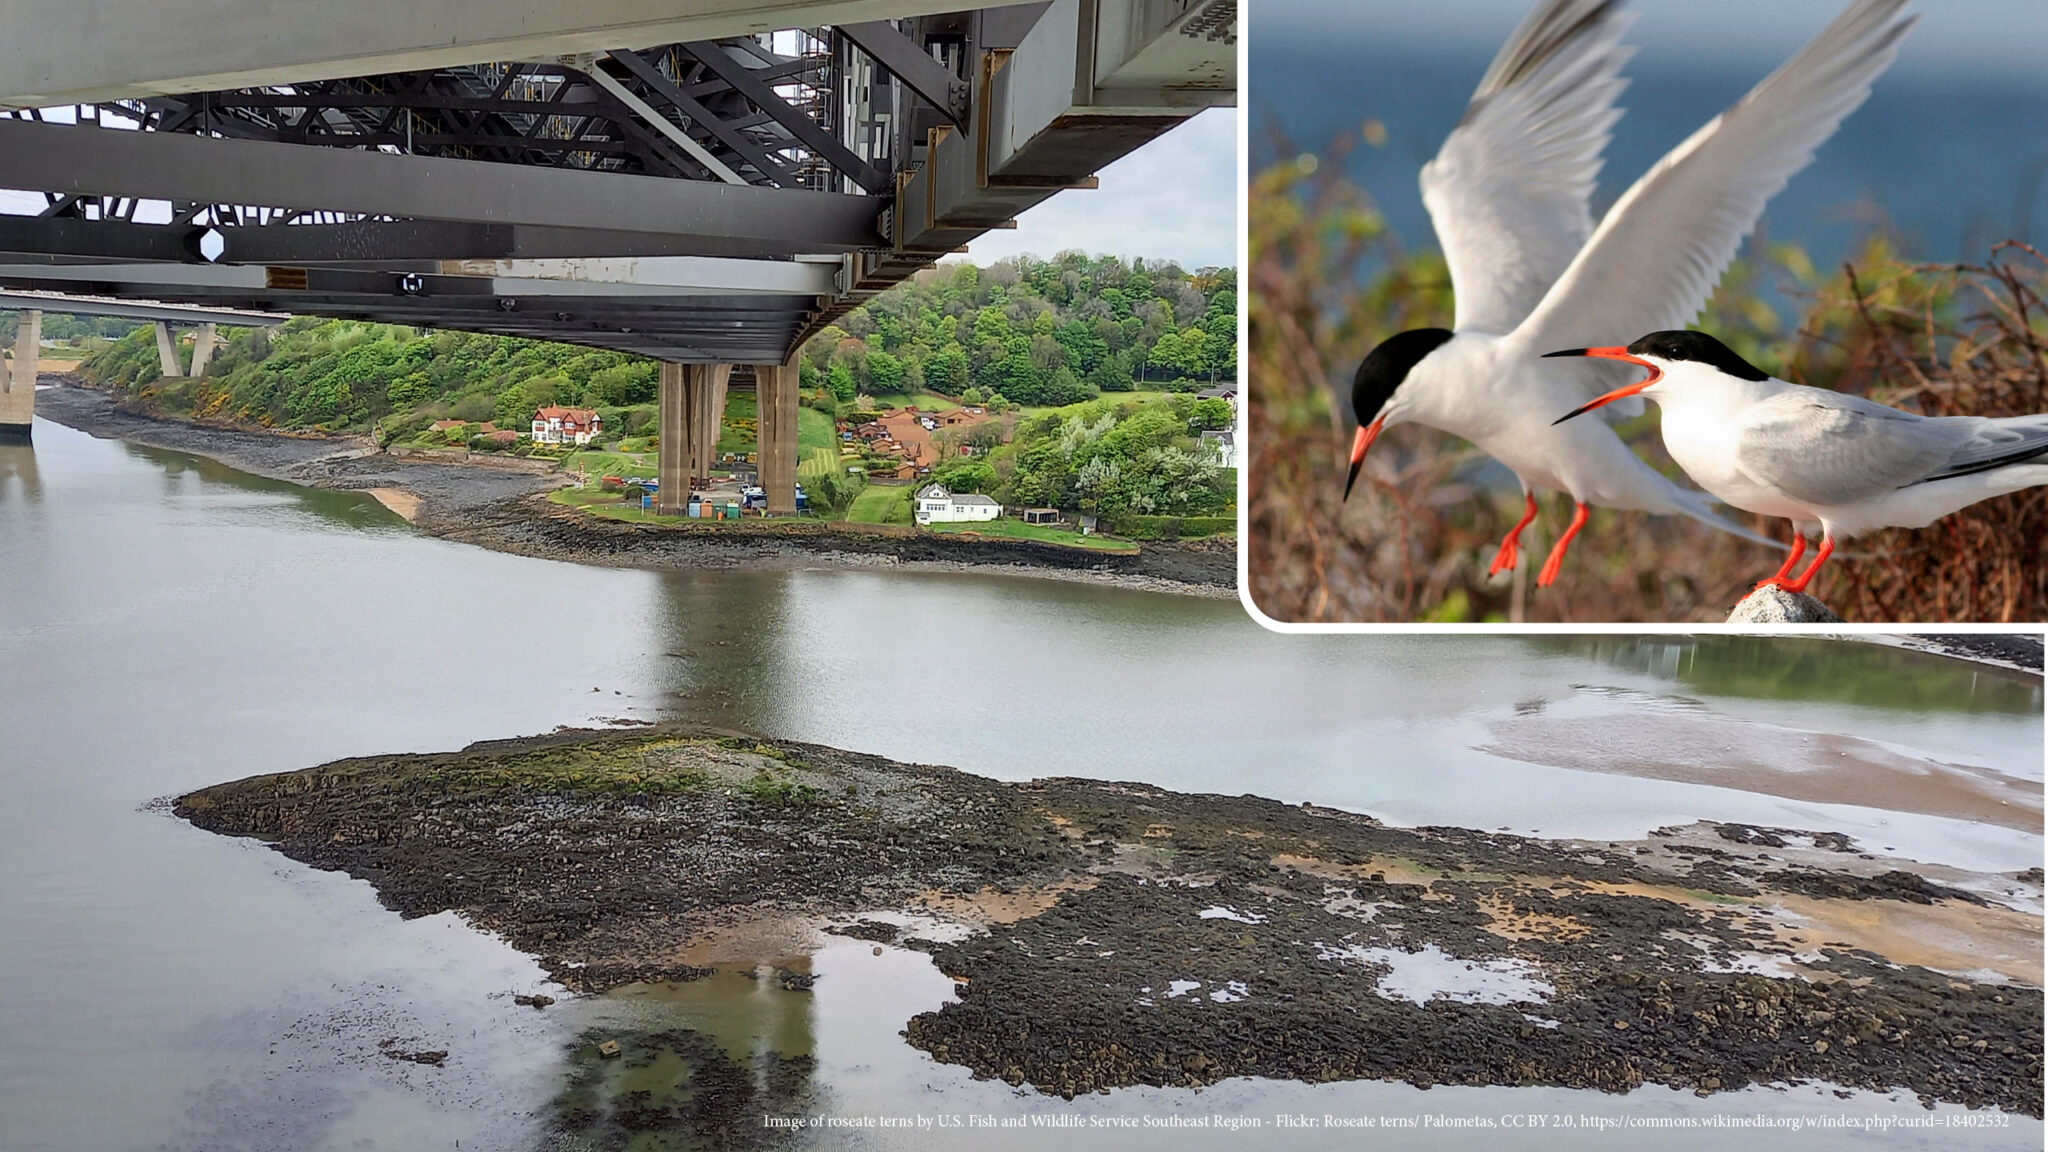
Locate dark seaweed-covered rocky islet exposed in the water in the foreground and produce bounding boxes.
[174,726,2042,1117]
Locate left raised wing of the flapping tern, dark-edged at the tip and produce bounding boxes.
[1421,0,1630,334]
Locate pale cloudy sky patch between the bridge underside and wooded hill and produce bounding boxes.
[967,109,1237,271]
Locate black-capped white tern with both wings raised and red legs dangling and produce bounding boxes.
[1343,0,1913,586]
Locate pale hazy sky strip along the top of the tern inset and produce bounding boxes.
[1245,0,2048,73]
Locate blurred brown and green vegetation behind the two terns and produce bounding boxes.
[1243,148,2048,623]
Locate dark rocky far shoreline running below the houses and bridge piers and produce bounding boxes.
[37,379,1237,599]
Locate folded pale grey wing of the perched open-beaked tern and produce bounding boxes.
[1735,387,1989,506]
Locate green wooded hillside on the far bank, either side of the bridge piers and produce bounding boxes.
[72,252,1237,440]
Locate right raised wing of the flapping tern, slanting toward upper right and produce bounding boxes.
[1516,0,1917,356]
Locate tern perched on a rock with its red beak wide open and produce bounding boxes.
[1548,332,2048,592]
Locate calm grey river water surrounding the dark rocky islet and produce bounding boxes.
[0,414,2042,1152]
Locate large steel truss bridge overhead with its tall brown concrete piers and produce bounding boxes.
[0,0,1237,504]
